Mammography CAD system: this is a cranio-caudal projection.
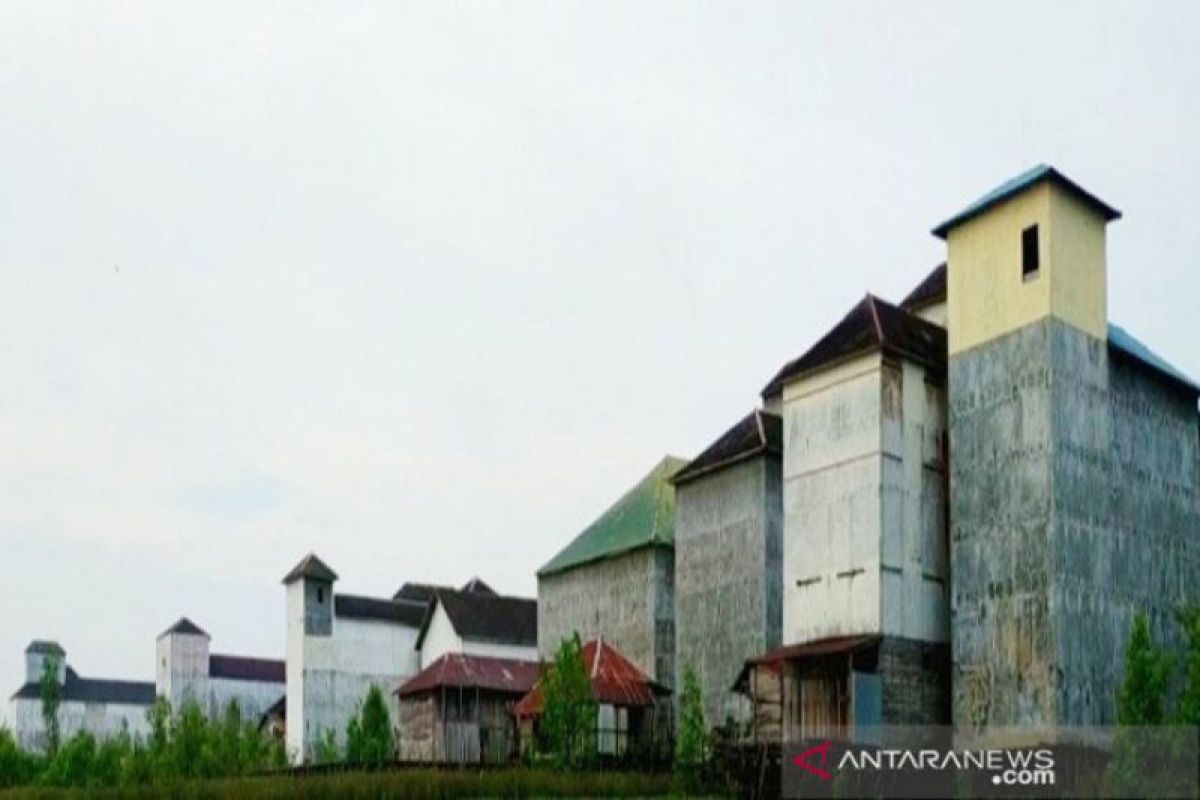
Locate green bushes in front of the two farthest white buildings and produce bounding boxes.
[0,698,287,789]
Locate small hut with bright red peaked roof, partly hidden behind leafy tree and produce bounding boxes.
[514,638,671,759]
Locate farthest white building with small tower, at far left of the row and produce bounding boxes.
[11,640,155,751]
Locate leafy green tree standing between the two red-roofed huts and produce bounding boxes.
[541,633,596,768]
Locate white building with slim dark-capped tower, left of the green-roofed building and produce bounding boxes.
[280,554,538,763]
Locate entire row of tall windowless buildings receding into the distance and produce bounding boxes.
[14,166,1200,760]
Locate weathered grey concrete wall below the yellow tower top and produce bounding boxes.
[949,319,1200,724]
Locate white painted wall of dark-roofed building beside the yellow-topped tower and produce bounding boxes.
[782,354,949,644]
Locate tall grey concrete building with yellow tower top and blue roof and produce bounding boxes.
[934,166,1200,726]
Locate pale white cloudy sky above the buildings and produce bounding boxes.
[0,2,1200,714]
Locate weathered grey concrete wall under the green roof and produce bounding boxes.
[538,547,674,686]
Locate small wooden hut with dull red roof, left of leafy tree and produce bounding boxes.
[396,652,538,764]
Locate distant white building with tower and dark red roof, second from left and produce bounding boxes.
[155,616,287,720]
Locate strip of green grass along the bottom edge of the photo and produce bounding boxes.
[0,769,696,800]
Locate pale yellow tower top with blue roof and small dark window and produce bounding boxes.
[934,164,1121,356]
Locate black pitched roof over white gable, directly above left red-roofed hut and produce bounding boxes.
[416,589,538,649]
